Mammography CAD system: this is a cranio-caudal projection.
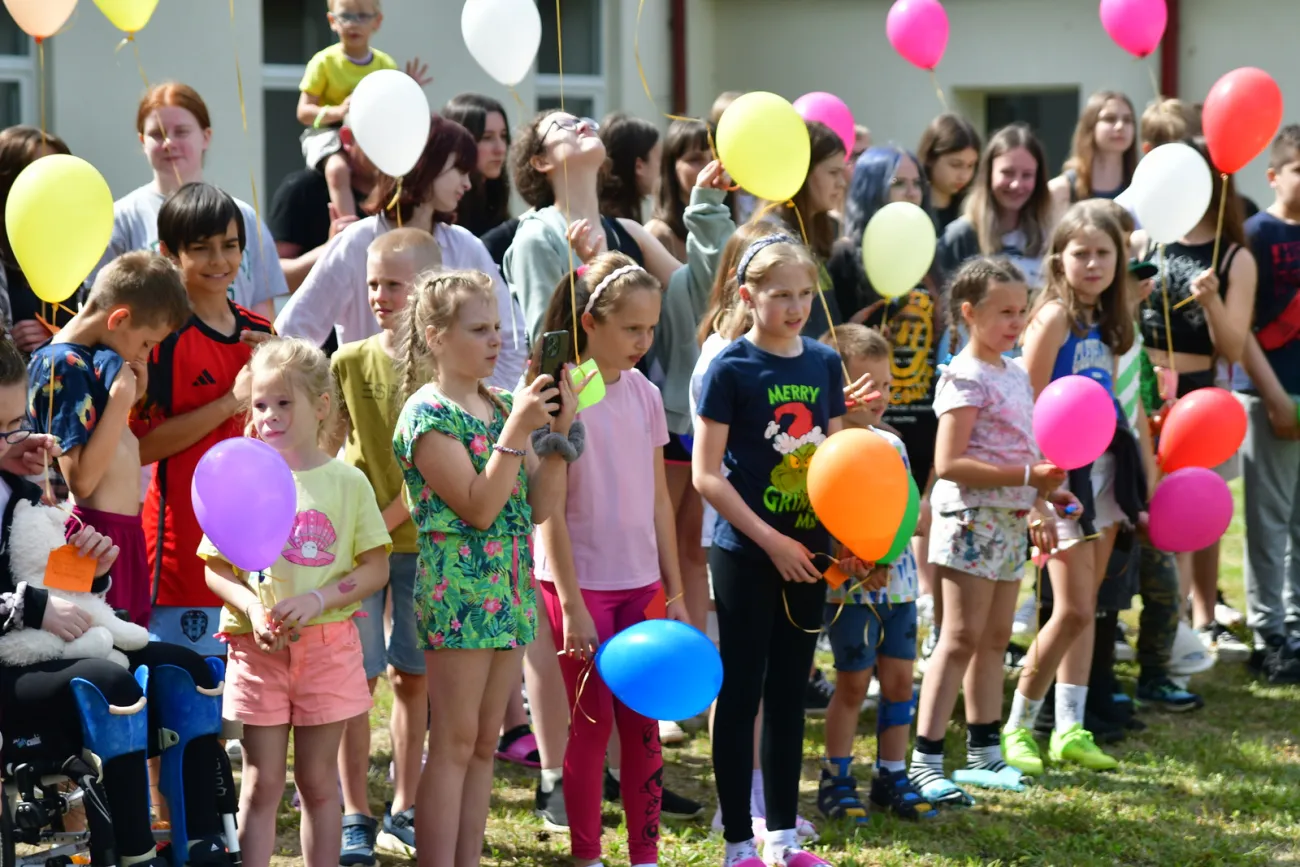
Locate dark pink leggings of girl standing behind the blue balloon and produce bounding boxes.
[537,581,663,864]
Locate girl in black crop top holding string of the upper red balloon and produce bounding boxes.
[1134,138,1258,662]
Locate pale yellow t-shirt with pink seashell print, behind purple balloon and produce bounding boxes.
[199,459,390,633]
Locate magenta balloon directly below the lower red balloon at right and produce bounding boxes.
[1148,467,1232,552]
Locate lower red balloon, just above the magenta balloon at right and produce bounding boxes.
[1158,389,1245,473]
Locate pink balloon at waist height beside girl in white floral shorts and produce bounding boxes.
[1034,376,1115,469]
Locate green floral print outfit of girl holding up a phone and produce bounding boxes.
[393,385,537,650]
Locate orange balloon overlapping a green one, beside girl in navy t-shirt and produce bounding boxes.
[807,428,907,563]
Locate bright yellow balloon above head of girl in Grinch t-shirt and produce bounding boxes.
[718,91,811,201]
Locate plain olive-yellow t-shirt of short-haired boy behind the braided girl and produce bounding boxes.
[330,334,420,554]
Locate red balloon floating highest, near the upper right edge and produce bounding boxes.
[1201,66,1282,174]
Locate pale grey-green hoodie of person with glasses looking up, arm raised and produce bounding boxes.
[502,187,736,434]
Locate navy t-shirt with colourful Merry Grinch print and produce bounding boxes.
[698,337,845,554]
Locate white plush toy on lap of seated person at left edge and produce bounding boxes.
[0,500,150,668]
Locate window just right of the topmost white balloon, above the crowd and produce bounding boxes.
[537,0,606,118]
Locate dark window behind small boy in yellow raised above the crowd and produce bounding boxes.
[261,0,335,201]
